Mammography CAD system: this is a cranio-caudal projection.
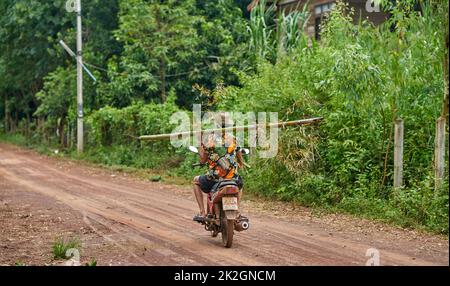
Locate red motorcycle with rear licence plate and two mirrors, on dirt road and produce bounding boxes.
[189,146,250,248]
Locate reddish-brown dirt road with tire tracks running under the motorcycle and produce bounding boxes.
[0,144,449,265]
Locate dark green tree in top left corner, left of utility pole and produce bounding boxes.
[0,0,70,133]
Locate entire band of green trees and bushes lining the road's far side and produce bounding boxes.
[0,0,449,233]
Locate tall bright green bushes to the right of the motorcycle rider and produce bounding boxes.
[220,2,448,232]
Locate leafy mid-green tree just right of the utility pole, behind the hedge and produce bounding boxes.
[103,0,199,102]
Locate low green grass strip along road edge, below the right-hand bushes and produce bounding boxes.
[247,181,449,236]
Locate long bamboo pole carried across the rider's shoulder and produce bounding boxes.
[139,117,323,141]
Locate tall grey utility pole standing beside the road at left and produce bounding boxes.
[75,0,84,153]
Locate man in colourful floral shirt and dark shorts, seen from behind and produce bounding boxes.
[193,115,244,222]
